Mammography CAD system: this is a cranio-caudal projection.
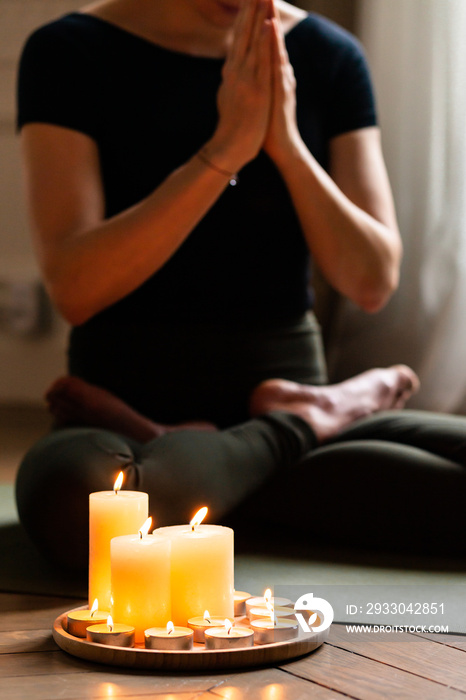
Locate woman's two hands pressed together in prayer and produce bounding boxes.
[207,0,300,172]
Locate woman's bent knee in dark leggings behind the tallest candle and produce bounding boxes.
[16,428,138,568]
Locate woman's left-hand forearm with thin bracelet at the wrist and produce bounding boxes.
[34,139,240,325]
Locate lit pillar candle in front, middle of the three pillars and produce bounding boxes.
[111,518,171,643]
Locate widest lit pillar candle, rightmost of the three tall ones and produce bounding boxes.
[155,508,234,625]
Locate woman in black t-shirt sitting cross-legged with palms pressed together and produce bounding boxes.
[17,0,465,565]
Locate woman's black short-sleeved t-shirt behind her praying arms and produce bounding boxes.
[18,13,376,332]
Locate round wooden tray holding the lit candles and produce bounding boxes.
[52,606,329,671]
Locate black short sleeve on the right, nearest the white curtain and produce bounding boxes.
[327,37,377,138]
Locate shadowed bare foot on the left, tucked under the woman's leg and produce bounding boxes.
[45,376,217,442]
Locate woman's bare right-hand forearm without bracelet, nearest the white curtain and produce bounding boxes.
[277,135,401,312]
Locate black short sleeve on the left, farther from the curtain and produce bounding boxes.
[17,20,97,138]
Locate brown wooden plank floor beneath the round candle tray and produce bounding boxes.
[0,593,466,700]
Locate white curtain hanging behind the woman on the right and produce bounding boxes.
[329,0,466,413]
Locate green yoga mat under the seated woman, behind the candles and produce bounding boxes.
[0,485,466,634]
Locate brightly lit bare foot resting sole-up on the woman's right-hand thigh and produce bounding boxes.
[249,365,419,442]
